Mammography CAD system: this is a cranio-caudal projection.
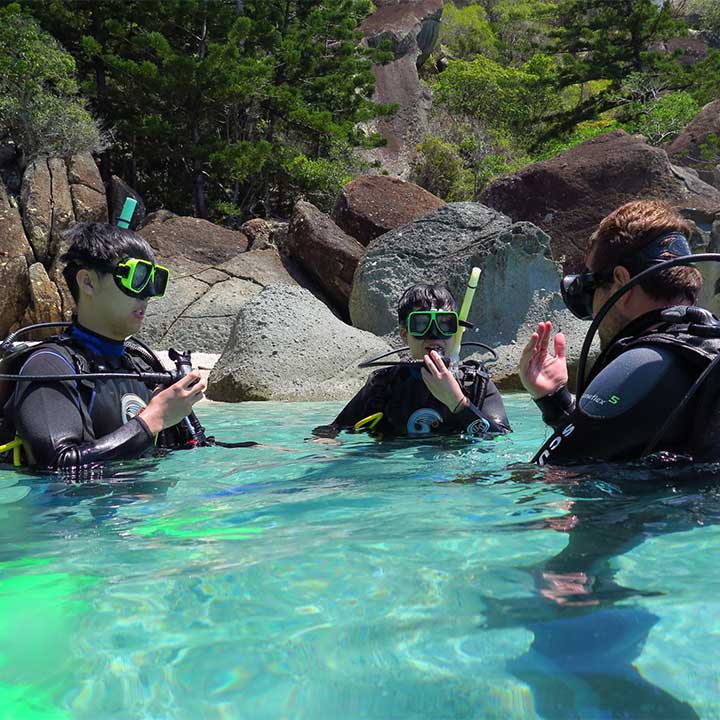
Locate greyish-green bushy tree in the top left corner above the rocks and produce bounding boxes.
[0,5,102,164]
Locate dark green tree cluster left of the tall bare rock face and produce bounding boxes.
[19,0,384,217]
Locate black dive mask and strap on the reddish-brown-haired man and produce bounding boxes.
[560,231,692,320]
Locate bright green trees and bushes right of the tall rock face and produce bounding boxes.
[415,0,720,199]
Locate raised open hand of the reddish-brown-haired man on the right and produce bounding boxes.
[518,322,568,399]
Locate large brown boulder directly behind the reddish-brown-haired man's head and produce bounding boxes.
[479,130,720,267]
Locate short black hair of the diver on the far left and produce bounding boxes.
[60,223,155,302]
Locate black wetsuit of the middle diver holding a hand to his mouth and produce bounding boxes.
[313,363,510,437]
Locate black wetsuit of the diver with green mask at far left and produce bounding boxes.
[3,325,184,470]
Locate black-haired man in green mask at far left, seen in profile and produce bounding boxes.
[2,223,206,472]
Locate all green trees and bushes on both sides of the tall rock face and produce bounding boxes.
[0,0,720,219]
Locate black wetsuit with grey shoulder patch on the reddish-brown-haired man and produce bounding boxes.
[533,307,720,465]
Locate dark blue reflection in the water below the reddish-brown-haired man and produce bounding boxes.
[484,458,720,720]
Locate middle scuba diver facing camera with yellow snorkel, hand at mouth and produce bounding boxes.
[313,282,510,438]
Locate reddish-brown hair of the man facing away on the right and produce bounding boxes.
[588,200,702,303]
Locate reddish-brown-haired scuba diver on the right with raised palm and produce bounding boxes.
[518,200,720,465]
